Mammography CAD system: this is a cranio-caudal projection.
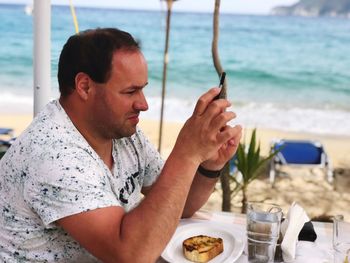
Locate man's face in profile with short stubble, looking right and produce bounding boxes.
[91,50,148,139]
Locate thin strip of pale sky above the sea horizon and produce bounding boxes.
[0,0,297,14]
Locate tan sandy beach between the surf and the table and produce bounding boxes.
[0,114,350,220]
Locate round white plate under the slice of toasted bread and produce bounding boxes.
[162,222,244,263]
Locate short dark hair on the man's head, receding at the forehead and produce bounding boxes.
[57,28,140,97]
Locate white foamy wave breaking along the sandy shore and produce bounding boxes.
[0,93,350,136]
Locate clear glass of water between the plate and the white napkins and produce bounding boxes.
[247,202,282,263]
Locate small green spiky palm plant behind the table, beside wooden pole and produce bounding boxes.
[232,129,278,213]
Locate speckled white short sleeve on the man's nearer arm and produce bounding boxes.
[24,149,121,226]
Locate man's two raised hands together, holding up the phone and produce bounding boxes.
[174,88,241,170]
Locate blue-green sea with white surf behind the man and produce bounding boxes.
[0,3,350,136]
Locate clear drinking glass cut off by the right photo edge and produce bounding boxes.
[333,215,350,263]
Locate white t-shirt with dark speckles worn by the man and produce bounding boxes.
[0,100,164,263]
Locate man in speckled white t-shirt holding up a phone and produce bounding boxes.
[0,29,241,263]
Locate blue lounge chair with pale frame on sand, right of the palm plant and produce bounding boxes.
[270,140,334,184]
